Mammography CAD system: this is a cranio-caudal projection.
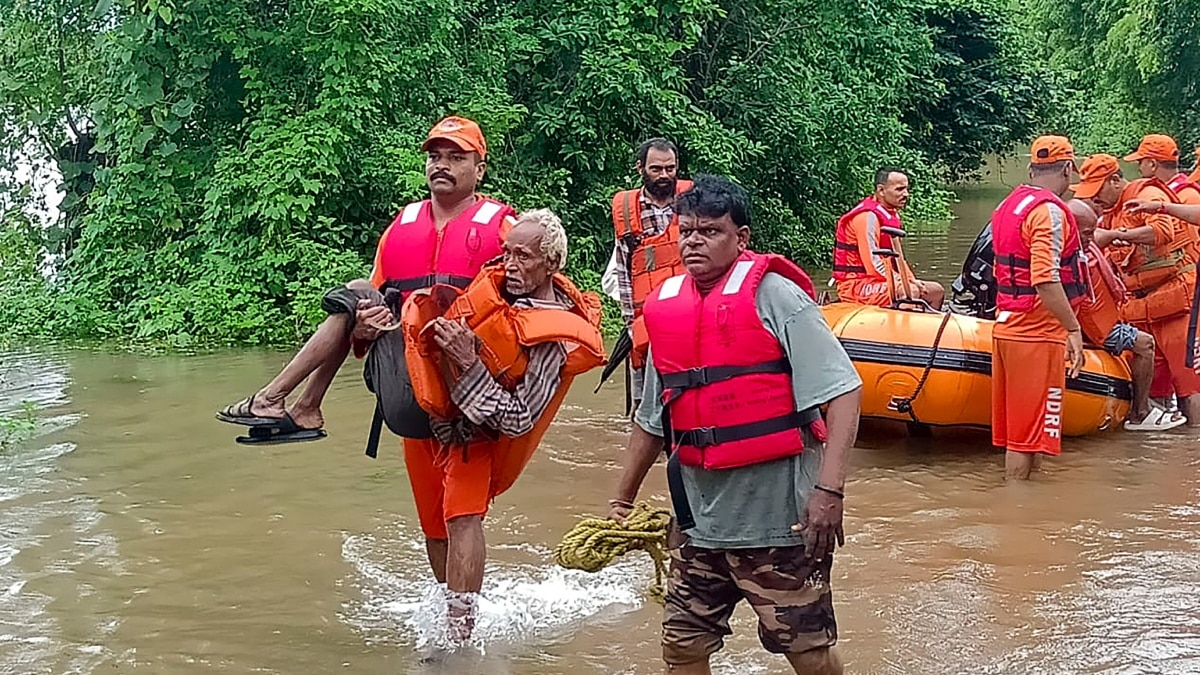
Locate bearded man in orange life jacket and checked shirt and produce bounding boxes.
[605,138,691,410]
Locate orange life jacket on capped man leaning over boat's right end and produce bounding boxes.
[1105,178,1196,322]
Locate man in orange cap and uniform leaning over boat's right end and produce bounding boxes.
[1073,155,1200,426]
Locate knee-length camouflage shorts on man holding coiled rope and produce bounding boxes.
[662,535,838,665]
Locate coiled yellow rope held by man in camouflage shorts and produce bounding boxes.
[554,502,671,603]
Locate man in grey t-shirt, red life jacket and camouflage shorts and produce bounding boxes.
[610,177,862,675]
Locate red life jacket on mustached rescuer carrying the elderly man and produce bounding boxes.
[376,196,515,298]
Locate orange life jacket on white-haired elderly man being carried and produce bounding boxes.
[401,264,605,425]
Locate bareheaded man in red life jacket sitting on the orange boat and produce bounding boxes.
[833,168,946,309]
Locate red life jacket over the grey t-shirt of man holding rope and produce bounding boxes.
[642,251,826,470]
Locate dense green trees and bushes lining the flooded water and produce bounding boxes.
[0,0,1200,347]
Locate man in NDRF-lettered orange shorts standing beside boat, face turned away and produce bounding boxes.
[991,136,1088,479]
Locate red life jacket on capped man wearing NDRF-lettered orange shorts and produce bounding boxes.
[991,185,1088,312]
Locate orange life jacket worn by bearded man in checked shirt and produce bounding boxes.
[612,180,692,369]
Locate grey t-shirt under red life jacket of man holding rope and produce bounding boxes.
[634,273,863,549]
